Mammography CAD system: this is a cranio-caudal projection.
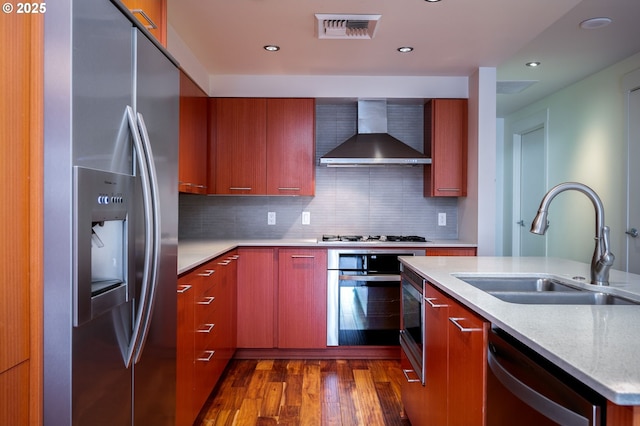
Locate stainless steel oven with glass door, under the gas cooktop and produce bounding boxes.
[327,248,424,346]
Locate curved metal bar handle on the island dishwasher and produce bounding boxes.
[487,350,589,426]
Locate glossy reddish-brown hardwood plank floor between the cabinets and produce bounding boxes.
[195,360,410,426]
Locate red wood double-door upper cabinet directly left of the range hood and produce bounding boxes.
[209,98,315,195]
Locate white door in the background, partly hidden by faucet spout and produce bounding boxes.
[515,127,546,256]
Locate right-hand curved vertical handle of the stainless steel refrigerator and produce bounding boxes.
[134,113,160,363]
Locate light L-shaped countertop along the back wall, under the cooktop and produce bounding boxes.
[178,238,476,275]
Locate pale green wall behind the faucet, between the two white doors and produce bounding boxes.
[500,54,640,268]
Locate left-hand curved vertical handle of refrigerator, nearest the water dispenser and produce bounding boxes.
[124,105,154,368]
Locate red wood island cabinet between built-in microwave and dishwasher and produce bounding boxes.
[401,283,489,426]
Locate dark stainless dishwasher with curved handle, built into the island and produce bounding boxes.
[486,329,606,426]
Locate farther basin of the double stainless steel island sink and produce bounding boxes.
[458,276,584,292]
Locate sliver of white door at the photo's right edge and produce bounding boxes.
[627,89,640,274]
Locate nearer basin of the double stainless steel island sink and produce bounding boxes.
[488,290,640,305]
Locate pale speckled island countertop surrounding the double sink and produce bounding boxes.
[401,256,640,405]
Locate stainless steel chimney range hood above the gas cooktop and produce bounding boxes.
[320,100,431,167]
